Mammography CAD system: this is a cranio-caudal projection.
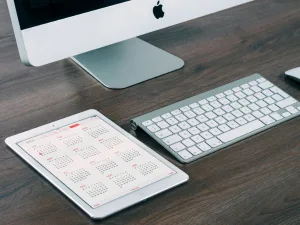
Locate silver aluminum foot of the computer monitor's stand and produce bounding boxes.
[72,38,184,89]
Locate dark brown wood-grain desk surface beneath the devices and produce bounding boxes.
[0,0,300,225]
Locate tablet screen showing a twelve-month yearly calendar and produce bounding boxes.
[18,116,176,208]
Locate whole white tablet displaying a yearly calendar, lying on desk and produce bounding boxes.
[5,110,188,219]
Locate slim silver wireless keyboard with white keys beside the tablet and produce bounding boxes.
[131,74,300,163]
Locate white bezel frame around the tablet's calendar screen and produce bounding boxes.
[5,110,189,219]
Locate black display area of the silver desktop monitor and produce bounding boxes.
[15,0,130,30]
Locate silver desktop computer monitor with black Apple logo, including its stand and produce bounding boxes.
[7,0,252,88]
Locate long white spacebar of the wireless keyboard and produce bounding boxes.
[218,120,265,143]
